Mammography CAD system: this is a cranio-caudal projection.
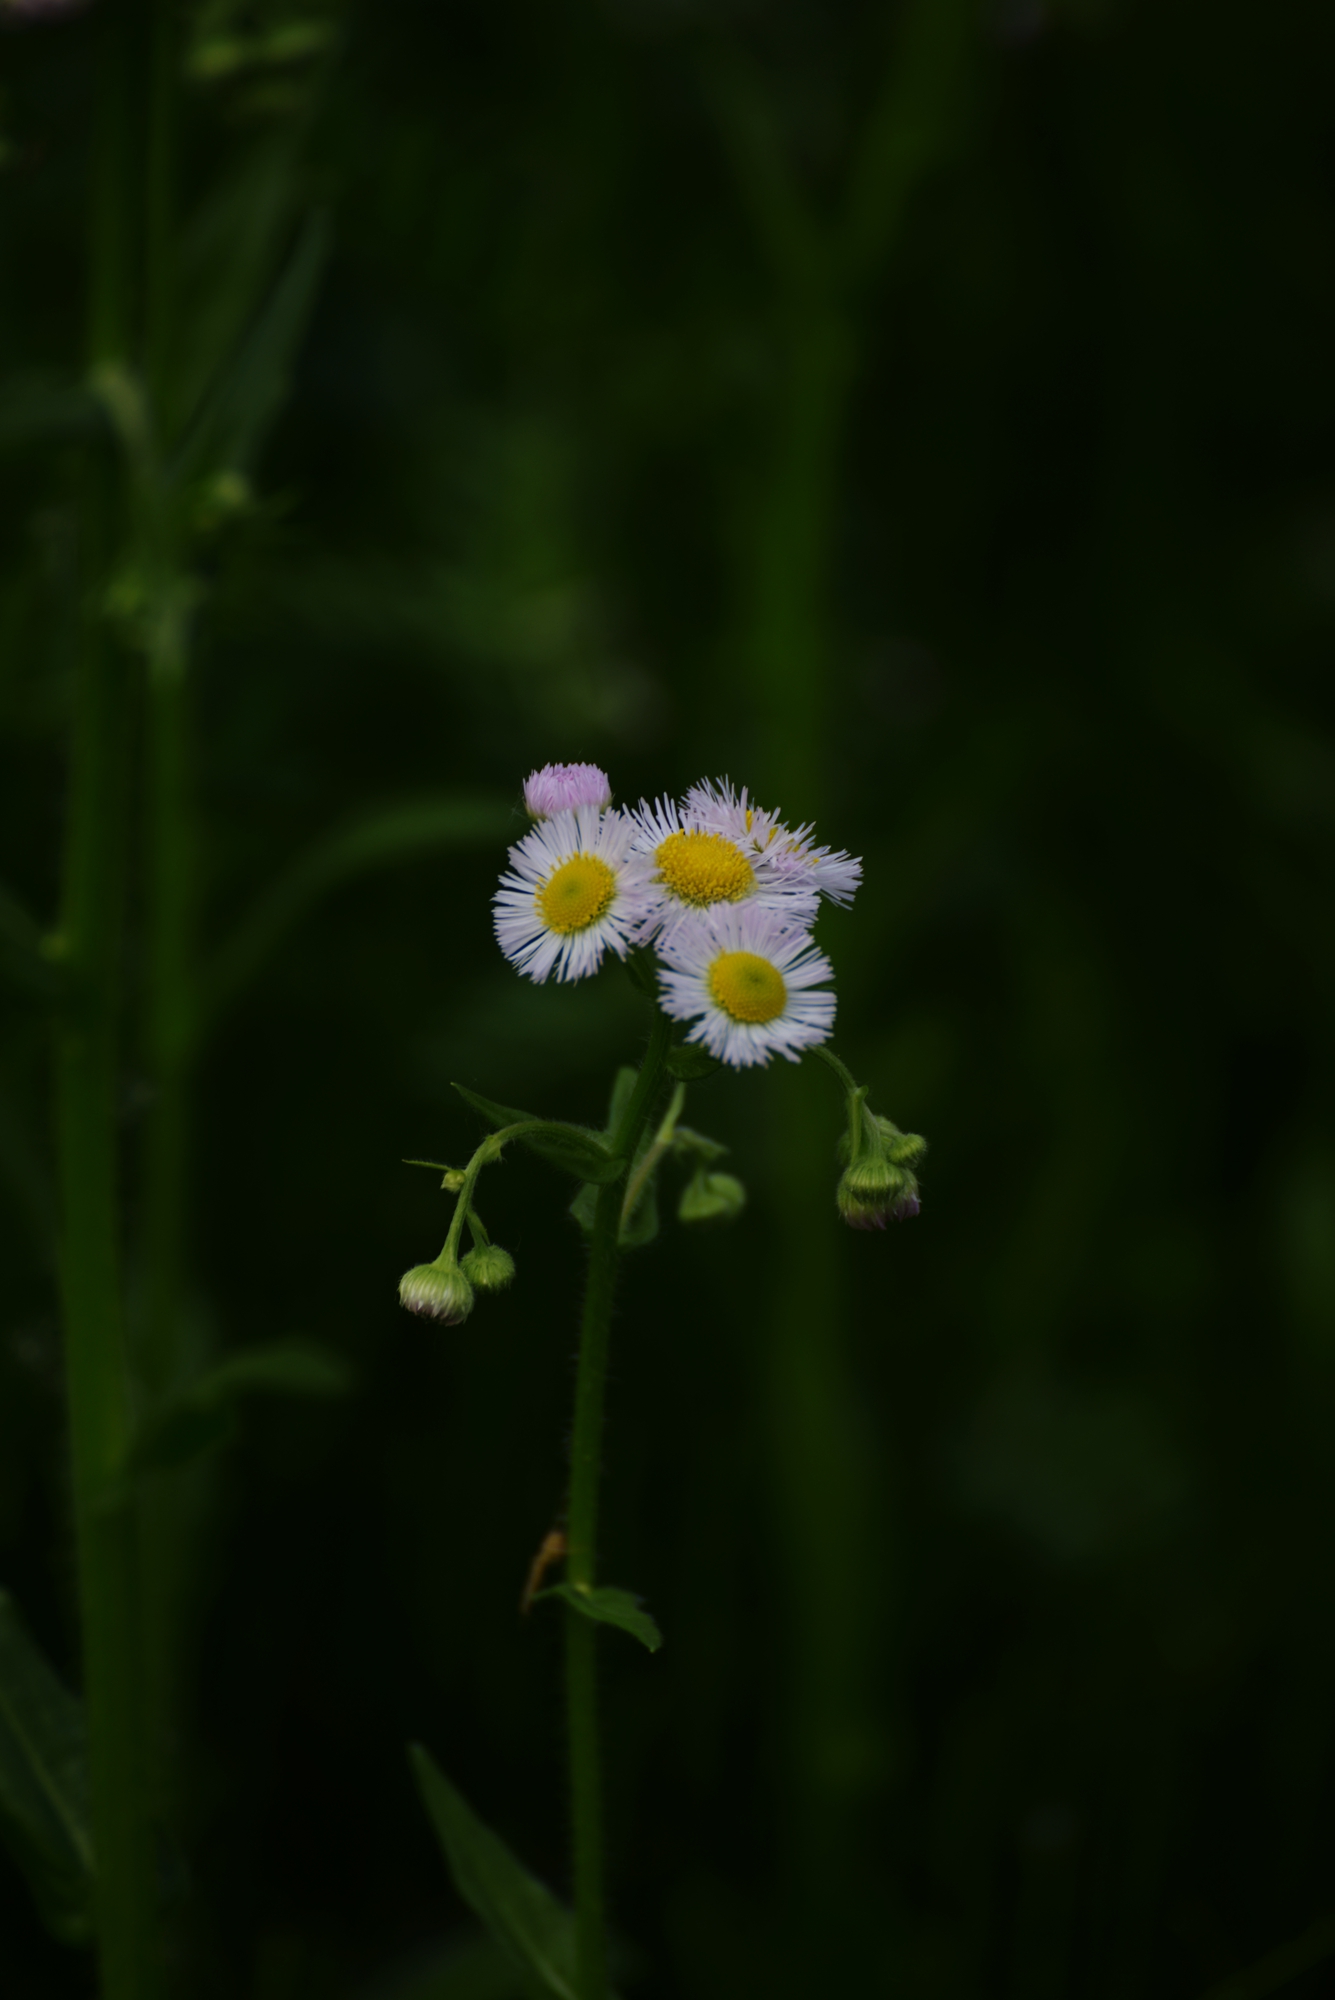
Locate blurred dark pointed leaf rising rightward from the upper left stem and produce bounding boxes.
[172,214,330,482]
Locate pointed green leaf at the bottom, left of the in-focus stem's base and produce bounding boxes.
[408,1744,578,2000]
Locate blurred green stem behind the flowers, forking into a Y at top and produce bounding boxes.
[707,0,975,1990]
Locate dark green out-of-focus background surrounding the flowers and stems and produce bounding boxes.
[0,0,1335,2000]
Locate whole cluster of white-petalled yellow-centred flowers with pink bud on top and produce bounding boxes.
[496,764,861,1068]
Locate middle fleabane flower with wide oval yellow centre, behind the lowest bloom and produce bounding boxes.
[632,798,819,936]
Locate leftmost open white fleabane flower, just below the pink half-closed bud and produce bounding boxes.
[494,806,654,980]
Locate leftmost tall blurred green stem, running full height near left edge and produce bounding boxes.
[56,7,160,2000]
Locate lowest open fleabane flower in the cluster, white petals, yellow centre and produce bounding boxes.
[658,902,835,1070]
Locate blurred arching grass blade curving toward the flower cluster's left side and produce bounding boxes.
[202,796,514,1026]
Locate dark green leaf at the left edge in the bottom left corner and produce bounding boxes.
[0,1590,92,1944]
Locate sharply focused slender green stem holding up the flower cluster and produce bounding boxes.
[566,1008,671,2000]
